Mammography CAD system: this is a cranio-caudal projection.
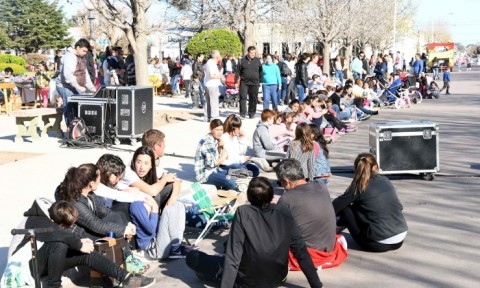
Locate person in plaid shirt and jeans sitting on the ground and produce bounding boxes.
[194,119,237,190]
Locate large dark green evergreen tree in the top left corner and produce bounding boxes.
[0,0,71,53]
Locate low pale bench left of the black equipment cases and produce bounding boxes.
[11,108,63,142]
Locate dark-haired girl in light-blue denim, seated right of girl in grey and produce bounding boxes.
[310,123,331,185]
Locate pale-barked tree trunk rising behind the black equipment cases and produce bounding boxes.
[90,0,153,85]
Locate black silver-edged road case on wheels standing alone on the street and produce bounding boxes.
[369,121,440,180]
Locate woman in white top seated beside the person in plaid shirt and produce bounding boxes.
[220,114,262,177]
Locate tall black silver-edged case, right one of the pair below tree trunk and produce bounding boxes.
[115,86,153,139]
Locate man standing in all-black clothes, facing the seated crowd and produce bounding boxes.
[235,46,262,118]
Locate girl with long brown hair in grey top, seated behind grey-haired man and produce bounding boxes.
[285,123,315,180]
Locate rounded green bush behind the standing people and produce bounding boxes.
[185,29,242,57]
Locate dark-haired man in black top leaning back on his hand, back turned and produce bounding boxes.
[186,177,322,288]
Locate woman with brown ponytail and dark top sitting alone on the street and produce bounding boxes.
[333,153,408,252]
